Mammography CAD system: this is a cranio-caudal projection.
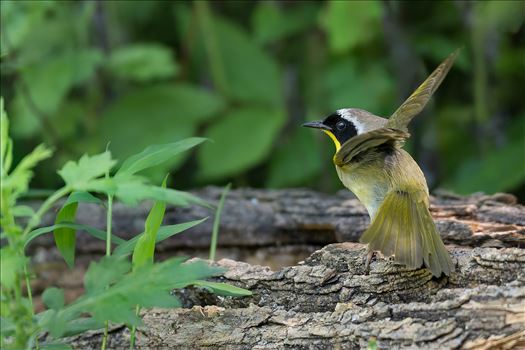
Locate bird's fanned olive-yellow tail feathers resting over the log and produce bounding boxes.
[360,191,454,277]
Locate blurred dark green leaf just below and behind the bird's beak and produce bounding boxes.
[266,127,322,188]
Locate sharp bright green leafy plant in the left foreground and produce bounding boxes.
[0,100,250,349]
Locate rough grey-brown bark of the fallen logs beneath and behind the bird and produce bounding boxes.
[29,188,525,349]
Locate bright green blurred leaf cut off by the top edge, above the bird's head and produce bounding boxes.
[320,0,383,54]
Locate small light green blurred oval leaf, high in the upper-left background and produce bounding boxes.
[108,43,178,82]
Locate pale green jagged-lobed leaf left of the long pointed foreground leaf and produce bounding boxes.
[58,151,116,191]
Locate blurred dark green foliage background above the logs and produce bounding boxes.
[1,1,525,202]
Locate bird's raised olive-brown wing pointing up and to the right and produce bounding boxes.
[386,49,459,130]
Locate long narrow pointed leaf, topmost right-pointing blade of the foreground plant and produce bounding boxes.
[116,137,206,176]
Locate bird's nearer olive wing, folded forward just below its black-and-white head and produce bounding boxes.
[334,128,410,166]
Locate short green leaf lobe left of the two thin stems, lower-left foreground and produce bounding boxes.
[84,256,131,294]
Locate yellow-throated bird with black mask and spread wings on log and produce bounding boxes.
[303,49,459,277]
